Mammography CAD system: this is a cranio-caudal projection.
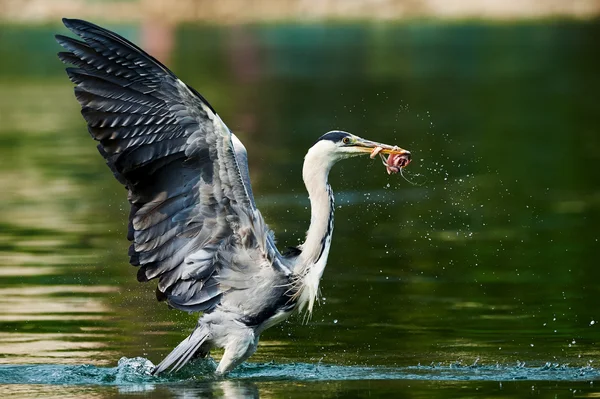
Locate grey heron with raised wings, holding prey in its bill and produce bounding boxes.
[55,18,411,376]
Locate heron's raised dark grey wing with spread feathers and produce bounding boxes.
[56,19,282,311]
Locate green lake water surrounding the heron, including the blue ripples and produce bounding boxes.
[0,22,600,398]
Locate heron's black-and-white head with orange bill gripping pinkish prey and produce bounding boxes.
[309,130,411,171]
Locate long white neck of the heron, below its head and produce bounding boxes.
[294,144,334,313]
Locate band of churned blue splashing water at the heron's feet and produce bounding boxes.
[0,357,600,390]
